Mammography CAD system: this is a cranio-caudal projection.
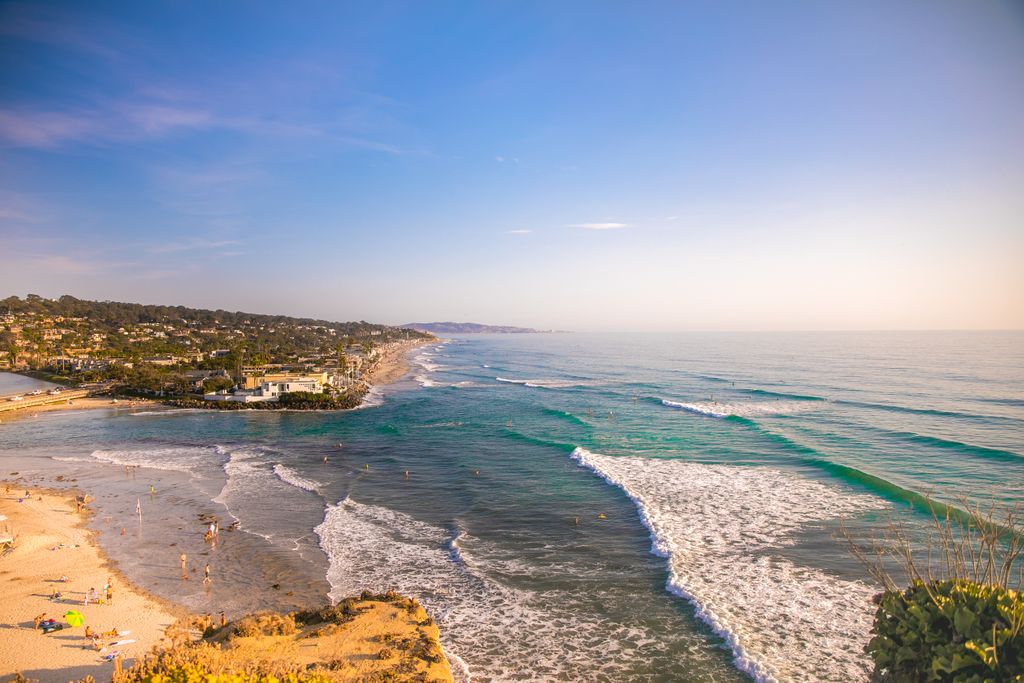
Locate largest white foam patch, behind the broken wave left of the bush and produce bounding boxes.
[572,447,885,682]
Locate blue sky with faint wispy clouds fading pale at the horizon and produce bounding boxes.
[0,0,1024,331]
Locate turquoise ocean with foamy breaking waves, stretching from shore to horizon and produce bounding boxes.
[0,333,1024,681]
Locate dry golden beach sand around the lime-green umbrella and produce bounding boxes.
[0,484,178,683]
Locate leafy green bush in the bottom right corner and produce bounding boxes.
[864,580,1024,683]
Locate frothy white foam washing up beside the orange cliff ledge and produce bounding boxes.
[315,499,696,681]
